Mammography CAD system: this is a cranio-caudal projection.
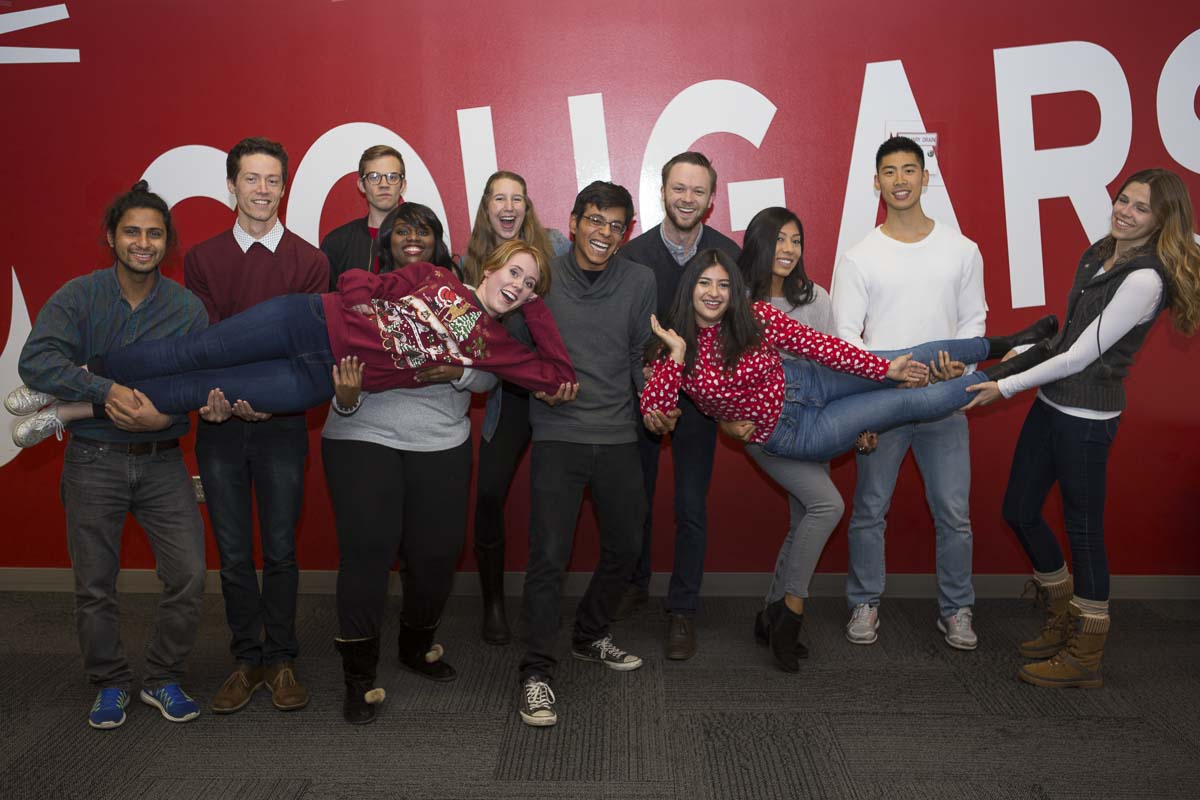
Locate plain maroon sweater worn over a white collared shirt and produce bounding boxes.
[184,229,329,323]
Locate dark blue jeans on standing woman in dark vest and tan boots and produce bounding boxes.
[1002,399,1121,600]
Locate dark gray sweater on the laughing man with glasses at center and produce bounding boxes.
[529,251,655,445]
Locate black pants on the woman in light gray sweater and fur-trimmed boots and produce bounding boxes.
[320,439,470,639]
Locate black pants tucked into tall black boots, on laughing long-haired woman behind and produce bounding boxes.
[475,383,529,554]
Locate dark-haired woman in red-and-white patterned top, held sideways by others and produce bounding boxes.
[641,249,1057,461]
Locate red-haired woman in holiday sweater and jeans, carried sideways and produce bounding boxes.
[6,236,575,446]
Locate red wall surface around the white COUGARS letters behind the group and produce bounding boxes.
[0,0,1200,575]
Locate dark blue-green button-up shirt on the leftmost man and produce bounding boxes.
[18,264,209,441]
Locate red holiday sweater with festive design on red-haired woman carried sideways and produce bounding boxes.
[323,263,576,393]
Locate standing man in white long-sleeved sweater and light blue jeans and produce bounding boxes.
[832,137,988,650]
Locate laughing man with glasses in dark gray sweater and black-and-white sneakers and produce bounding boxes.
[508,181,654,726]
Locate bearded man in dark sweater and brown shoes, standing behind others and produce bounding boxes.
[617,151,742,660]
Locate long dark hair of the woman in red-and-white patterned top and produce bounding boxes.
[648,248,762,372]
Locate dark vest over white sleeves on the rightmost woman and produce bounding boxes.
[1042,237,1171,411]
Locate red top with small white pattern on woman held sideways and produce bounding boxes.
[642,302,888,444]
